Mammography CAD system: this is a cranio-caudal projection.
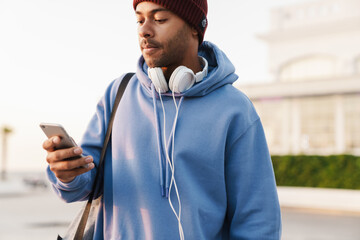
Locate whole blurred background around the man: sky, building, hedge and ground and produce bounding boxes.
[0,0,360,240]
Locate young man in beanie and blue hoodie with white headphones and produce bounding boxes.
[43,0,281,240]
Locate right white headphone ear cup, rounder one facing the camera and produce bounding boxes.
[169,66,195,93]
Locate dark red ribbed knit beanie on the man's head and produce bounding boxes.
[133,0,208,44]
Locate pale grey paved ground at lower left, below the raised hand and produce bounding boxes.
[0,190,81,240]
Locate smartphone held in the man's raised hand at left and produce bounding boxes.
[40,123,83,160]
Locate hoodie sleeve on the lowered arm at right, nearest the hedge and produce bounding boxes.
[225,119,281,240]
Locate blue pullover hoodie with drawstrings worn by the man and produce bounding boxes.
[47,42,281,240]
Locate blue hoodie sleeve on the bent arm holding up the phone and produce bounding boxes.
[47,80,120,202]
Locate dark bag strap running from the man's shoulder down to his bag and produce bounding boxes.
[74,73,134,240]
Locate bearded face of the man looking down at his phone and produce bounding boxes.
[136,2,192,69]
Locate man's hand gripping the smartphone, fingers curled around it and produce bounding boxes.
[43,136,95,183]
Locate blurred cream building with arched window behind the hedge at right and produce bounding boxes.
[239,0,360,155]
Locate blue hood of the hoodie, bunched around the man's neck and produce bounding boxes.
[136,41,238,97]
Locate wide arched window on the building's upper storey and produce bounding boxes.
[280,56,336,82]
